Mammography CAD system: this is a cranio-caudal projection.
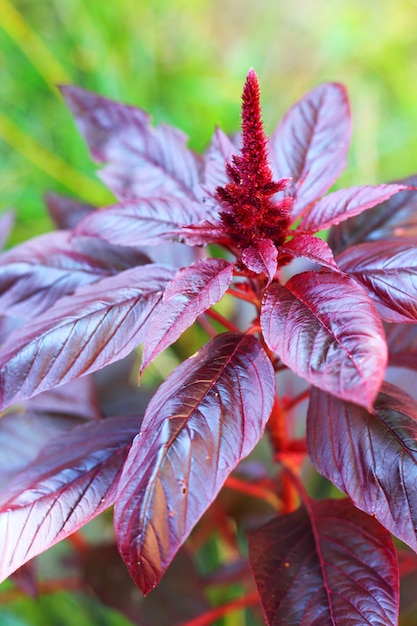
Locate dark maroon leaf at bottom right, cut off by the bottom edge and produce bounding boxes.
[249,500,399,626]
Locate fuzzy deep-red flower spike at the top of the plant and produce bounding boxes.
[216,69,292,250]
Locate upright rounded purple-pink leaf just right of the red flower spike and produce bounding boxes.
[270,83,351,217]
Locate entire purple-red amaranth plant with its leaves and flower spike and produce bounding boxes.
[0,70,417,626]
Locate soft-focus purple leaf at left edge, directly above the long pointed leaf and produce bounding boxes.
[0,231,149,319]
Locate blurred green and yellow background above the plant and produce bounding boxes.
[0,0,417,242]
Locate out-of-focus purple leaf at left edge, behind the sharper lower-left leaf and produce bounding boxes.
[0,377,98,488]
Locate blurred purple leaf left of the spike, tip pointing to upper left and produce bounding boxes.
[62,86,200,200]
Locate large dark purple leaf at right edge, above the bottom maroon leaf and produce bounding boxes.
[307,383,417,550]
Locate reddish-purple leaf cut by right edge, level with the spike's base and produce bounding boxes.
[336,239,417,323]
